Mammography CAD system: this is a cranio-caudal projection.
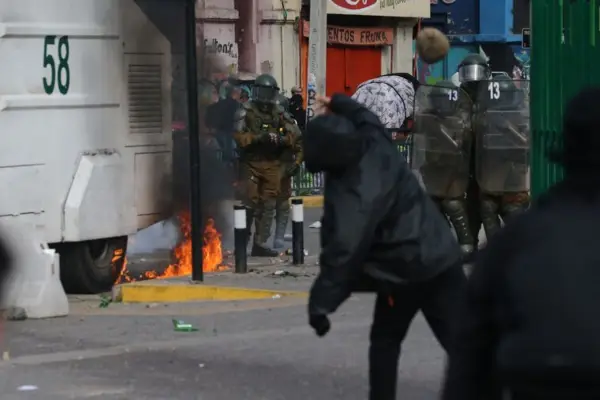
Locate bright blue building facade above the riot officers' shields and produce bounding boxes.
[417,0,530,83]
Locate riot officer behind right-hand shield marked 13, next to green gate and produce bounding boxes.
[475,76,529,239]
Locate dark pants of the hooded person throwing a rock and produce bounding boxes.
[369,265,467,400]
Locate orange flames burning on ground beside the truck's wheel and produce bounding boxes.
[112,213,229,284]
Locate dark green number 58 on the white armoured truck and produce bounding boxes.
[42,36,71,95]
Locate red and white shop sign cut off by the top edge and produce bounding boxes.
[327,0,431,18]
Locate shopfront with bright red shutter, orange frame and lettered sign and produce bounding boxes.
[300,0,430,94]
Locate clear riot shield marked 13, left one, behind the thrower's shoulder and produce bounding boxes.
[411,85,472,198]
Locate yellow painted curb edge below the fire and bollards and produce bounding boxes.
[113,283,308,303]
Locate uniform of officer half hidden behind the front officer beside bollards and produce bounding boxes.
[273,94,304,249]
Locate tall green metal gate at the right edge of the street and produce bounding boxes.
[531,0,600,196]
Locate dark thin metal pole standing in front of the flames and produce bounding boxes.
[185,0,204,282]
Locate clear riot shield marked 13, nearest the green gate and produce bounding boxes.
[474,80,530,193]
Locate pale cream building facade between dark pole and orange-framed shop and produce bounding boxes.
[196,0,301,94]
